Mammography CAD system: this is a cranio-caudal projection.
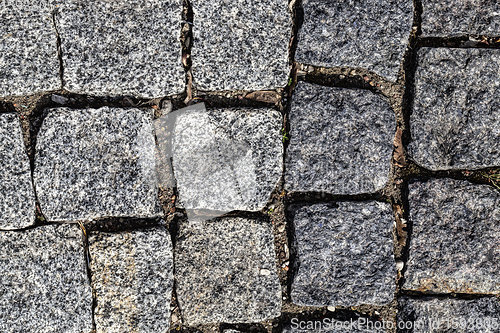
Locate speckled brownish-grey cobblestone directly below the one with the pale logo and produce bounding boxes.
[175,218,281,325]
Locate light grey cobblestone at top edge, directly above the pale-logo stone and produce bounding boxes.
[191,0,292,90]
